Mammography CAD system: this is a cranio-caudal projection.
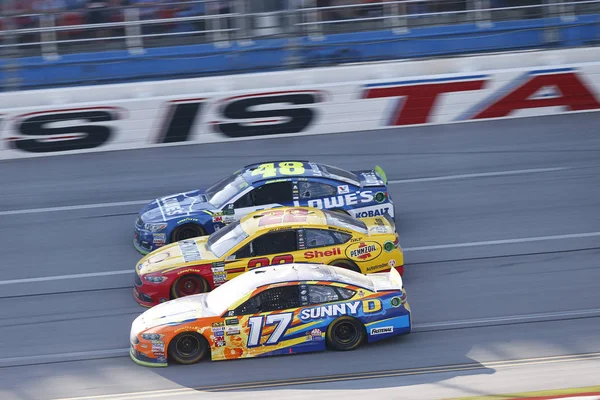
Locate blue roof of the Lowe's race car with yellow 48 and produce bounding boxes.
[240,160,360,186]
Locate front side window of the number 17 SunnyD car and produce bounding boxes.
[234,285,300,315]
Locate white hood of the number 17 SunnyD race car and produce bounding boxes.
[132,293,216,334]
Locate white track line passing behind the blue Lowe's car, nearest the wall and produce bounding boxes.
[0,167,572,216]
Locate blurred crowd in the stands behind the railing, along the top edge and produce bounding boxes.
[0,0,543,33]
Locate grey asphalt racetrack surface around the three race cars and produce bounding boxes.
[0,113,600,400]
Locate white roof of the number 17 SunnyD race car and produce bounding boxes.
[246,263,375,290]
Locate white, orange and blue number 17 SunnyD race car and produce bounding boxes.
[130,264,412,367]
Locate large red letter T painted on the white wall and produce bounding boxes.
[363,78,485,125]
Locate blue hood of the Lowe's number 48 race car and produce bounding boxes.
[140,190,214,223]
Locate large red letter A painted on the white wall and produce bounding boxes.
[472,71,600,119]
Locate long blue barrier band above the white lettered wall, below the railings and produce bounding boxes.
[0,15,600,89]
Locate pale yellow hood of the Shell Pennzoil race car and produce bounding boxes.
[136,236,217,275]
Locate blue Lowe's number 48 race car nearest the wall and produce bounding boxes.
[133,161,394,254]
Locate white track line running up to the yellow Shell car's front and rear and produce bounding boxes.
[0,232,600,285]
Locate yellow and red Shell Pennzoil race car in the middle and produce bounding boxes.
[133,207,404,307]
